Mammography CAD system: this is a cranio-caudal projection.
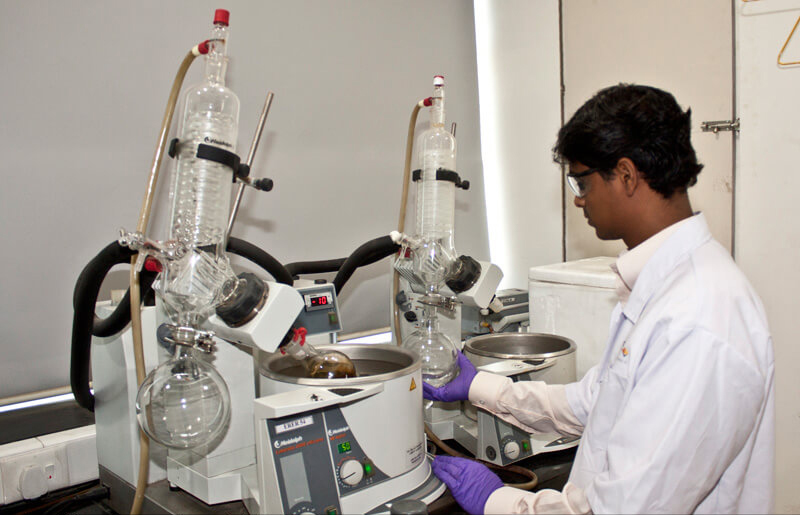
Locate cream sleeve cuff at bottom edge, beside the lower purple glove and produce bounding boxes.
[483,483,592,514]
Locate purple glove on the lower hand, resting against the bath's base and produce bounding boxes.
[431,456,503,515]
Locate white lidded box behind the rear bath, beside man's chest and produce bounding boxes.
[528,257,617,380]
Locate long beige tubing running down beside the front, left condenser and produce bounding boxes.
[130,47,200,515]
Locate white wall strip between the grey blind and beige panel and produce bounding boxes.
[475,0,563,290]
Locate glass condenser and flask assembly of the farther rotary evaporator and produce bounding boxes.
[392,75,503,386]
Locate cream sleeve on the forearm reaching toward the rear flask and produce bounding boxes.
[469,372,583,436]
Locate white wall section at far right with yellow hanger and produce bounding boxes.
[735,0,800,513]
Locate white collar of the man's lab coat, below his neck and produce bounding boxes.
[622,213,711,324]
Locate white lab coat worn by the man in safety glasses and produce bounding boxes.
[470,215,775,513]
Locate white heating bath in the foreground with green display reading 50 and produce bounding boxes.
[255,344,445,514]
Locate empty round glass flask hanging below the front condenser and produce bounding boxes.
[136,346,231,449]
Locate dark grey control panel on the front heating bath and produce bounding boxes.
[266,407,389,515]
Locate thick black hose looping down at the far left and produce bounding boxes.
[69,241,143,411]
